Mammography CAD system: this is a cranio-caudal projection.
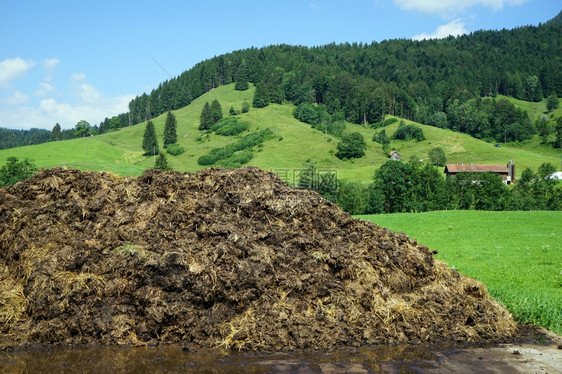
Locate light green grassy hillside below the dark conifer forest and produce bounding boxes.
[0,84,562,182]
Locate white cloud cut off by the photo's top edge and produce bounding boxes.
[394,0,527,16]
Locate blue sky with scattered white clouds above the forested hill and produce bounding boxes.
[0,0,562,129]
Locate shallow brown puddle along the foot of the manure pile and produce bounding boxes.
[0,346,436,374]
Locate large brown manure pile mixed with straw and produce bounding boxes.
[0,168,518,351]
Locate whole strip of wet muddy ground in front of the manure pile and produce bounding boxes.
[0,332,562,374]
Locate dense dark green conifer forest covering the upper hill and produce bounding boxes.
[119,17,562,132]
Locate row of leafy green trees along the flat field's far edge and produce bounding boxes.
[299,160,562,214]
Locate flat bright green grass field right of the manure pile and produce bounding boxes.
[358,211,562,334]
